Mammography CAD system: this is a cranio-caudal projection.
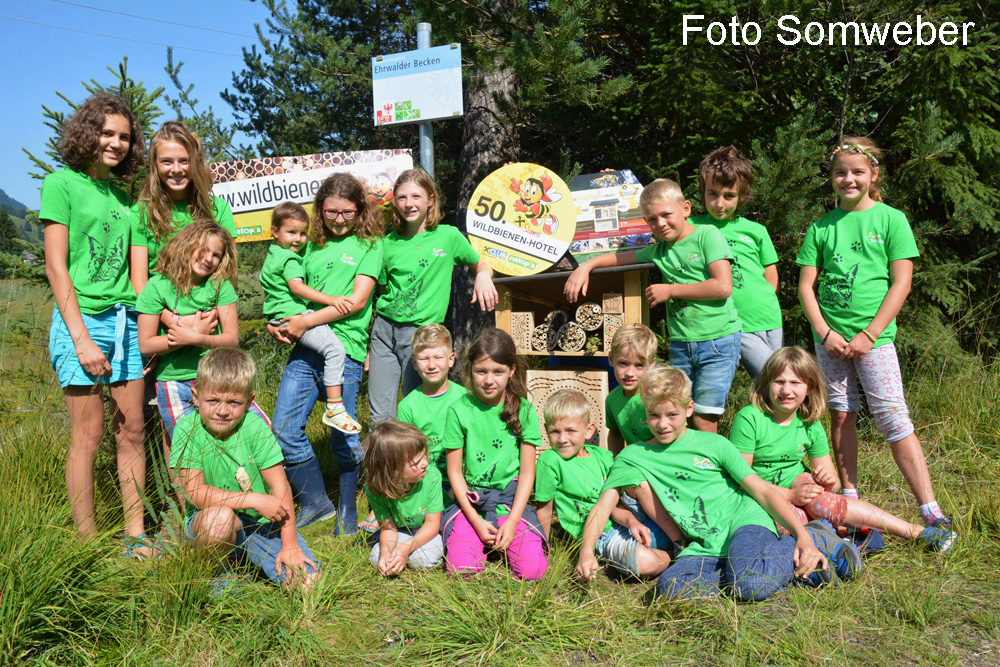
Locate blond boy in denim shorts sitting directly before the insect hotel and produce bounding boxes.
[535,389,670,577]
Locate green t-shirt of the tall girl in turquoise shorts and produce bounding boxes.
[38,167,135,315]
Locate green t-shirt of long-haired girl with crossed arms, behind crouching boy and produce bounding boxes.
[135,275,236,382]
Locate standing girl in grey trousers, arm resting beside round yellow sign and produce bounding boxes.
[368,169,497,424]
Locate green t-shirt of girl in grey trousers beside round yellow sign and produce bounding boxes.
[376,225,479,326]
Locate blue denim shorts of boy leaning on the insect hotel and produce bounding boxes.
[670,331,742,415]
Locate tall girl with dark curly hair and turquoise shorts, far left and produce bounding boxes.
[38,93,153,557]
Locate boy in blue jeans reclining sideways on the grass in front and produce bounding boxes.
[576,367,862,601]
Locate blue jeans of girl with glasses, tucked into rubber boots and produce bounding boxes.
[272,345,364,472]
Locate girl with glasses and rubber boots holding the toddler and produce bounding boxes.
[268,173,383,535]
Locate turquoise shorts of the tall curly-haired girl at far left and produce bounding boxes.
[49,304,142,387]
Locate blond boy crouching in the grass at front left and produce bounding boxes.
[170,347,319,592]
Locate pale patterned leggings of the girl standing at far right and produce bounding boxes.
[816,343,913,442]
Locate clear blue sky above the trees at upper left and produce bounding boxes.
[0,0,269,210]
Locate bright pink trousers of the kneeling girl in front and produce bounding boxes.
[444,512,549,580]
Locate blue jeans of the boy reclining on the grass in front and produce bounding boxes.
[656,525,795,602]
